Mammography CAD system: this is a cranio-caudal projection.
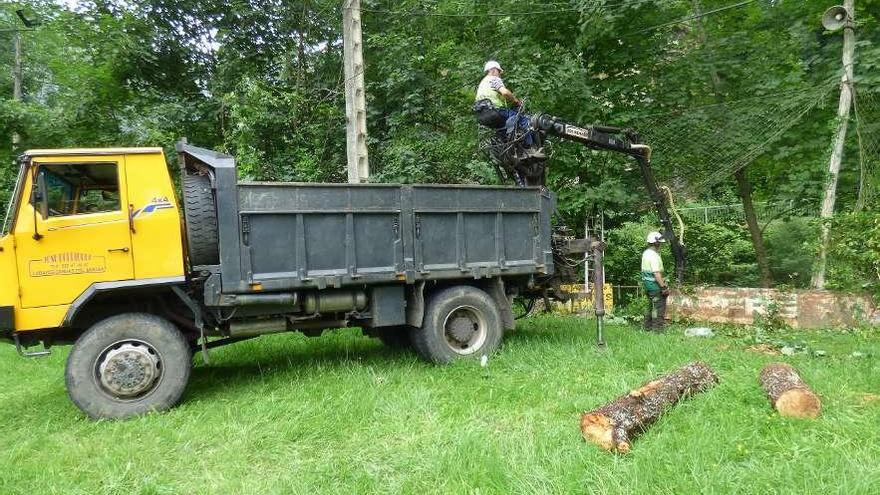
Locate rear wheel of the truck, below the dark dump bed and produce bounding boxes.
[410,285,504,364]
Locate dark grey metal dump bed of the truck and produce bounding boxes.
[178,144,554,293]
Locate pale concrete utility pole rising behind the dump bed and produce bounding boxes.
[342,0,370,184]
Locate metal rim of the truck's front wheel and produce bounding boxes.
[95,340,162,401]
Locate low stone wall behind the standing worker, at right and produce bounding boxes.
[668,287,880,328]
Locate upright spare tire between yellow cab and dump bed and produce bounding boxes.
[183,174,220,266]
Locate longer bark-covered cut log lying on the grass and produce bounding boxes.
[581,362,718,453]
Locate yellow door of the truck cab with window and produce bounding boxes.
[15,156,133,308]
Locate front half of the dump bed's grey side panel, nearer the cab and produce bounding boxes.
[239,184,404,289]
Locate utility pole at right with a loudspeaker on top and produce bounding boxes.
[810,0,856,289]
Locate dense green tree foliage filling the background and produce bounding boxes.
[0,0,880,286]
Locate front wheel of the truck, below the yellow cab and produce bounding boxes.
[65,313,192,419]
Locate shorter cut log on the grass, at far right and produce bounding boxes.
[760,363,822,418]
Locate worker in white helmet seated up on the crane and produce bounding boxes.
[473,60,546,160]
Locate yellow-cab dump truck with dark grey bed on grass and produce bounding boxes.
[0,143,554,418]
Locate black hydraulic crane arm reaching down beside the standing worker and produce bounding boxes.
[532,114,685,282]
